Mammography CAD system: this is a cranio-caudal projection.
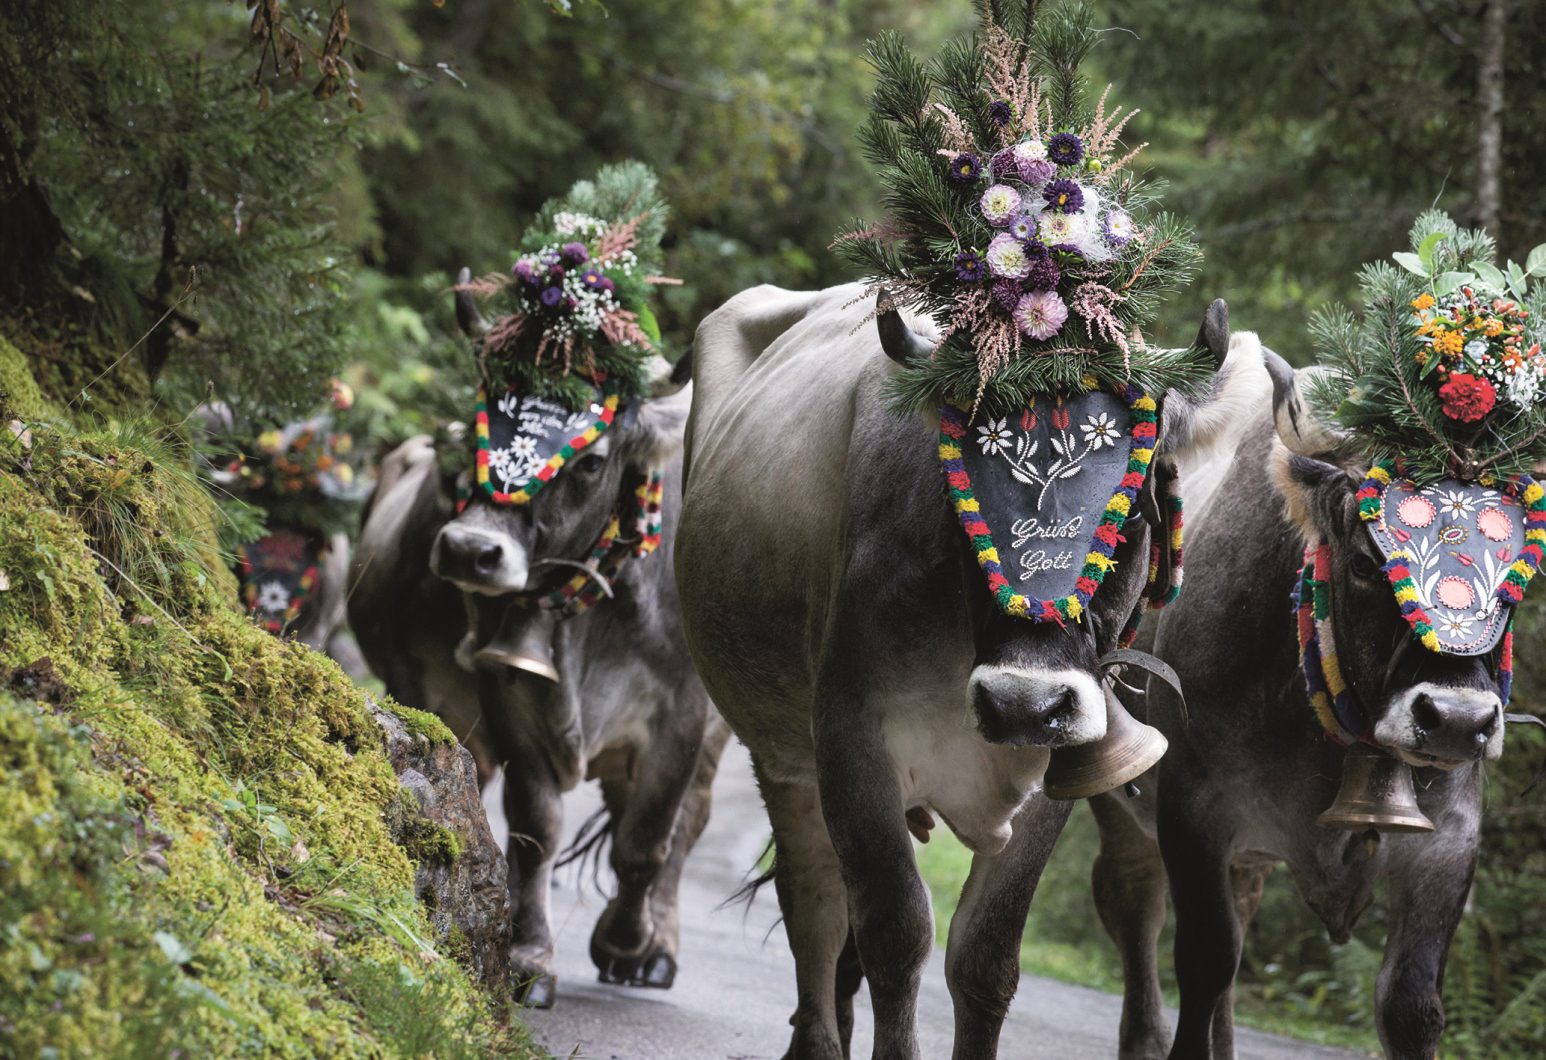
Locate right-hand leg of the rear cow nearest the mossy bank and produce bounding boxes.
[591,691,708,987]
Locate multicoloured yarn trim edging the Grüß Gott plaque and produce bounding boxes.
[940,385,1160,624]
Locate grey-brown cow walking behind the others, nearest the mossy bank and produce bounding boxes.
[349,272,728,1007]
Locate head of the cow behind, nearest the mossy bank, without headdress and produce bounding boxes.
[430,269,691,596]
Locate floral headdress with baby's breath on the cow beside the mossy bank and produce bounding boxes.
[458,162,677,413]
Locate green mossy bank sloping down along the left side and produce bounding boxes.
[0,352,535,1057]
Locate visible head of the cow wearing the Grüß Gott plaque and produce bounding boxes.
[877,300,1269,748]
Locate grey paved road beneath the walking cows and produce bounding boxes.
[495,743,1357,1060]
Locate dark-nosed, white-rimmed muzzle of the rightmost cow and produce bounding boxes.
[1374,683,1503,770]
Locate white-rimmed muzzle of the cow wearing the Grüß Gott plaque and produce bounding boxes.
[966,664,1105,748]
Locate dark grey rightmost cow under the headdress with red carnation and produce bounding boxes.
[1091,335,1527,1060]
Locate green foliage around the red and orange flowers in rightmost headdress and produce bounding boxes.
[1311,210,1546,481]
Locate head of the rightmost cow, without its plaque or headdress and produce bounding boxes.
[1266,351,1503,768]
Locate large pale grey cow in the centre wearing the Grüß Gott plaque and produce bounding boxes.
[676,284,1266,1060]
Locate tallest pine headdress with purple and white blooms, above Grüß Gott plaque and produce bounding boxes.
[836,2,1207,414]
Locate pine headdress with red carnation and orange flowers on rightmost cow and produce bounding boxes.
[1311,210,1546,482]
